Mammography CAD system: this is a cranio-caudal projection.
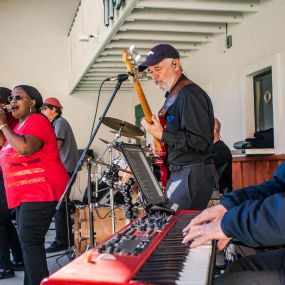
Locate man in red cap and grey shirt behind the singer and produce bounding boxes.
[41,97,79,253]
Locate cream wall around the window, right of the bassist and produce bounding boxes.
[139,0,285,153]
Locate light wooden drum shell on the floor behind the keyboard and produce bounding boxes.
[74,206,126,256]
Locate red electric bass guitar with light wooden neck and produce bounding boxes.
[123,49,168,187]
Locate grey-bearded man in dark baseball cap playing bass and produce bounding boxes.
[139,44,217,210]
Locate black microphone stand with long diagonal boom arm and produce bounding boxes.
[56,78,127,247]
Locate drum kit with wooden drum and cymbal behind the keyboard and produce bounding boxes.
[74,117,155,256]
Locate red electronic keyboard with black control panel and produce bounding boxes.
[42,211,215,285]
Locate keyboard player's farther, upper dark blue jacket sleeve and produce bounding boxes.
[221,162,285,210]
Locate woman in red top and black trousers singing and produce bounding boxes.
[0,85,68,285]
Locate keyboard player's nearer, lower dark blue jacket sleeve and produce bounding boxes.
[221,192,285,247]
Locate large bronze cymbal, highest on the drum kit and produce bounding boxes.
[102,117,144,138]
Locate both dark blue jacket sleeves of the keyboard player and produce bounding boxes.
[221,162,285,246]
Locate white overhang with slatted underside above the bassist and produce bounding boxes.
[68,0,265,93]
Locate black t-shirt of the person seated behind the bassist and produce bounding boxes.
[213,141,232,193]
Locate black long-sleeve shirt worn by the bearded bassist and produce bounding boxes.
[161,75,214,165]
